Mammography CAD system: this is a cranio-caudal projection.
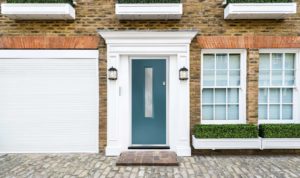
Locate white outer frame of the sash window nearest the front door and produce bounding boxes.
[200,49,247,124]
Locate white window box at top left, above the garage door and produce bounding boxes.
[1,3,75,20]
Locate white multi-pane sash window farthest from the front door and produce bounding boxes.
[258,50,299,123]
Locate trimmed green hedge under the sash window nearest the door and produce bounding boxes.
[194,124,258,138]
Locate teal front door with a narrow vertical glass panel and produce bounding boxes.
[132,59,167,145]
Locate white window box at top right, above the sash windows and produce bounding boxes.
[224,3,297,19]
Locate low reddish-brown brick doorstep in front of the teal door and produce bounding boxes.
[116,151,179,166]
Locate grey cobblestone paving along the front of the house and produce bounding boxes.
[0,154,300,178]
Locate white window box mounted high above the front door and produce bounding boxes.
[116,3,182,20]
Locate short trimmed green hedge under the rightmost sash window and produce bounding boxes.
[259,124,300,138]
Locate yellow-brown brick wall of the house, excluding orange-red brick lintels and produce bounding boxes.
[0,0,300,149]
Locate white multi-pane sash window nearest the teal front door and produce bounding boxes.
[201,50,246,124]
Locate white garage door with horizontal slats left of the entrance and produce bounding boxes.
[0,50,99,153]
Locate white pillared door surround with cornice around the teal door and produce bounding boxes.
[99,31,197,156]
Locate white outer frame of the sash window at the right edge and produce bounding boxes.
[257,49,300,124]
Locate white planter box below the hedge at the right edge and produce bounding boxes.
[262,138,300,149]
